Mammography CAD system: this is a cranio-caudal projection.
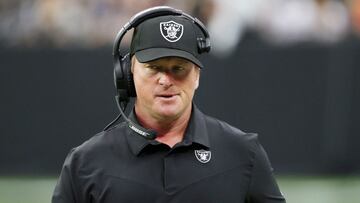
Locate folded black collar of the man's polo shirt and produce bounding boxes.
[126,105,210,155]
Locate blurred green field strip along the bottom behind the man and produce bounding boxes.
[0,176,360,203]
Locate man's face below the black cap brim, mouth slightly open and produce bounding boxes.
[132,57,200,121]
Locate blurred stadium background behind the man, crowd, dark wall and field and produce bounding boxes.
[0,0,360,203]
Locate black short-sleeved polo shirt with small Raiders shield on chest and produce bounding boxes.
[52,105,285,203]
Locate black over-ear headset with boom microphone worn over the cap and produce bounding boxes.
[104,6,211,139]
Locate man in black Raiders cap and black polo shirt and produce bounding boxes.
[52,6,285,203]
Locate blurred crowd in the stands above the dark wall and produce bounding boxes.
[0,0,360,54]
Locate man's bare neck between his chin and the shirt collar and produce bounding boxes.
[135,105,192,147]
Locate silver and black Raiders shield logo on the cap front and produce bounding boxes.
[160,21,184,42]
